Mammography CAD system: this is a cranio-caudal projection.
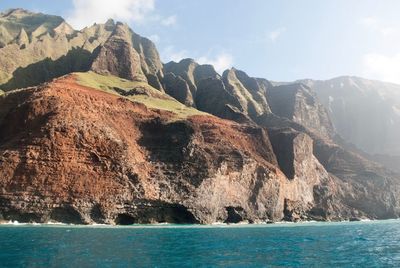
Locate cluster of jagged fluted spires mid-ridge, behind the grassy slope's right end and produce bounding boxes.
[164,59,272,122]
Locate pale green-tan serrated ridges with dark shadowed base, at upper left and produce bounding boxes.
[0,9,103,90]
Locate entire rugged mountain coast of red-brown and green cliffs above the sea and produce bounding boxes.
[0,9,400,224]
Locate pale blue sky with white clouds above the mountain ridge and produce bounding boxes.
[0,0,400,83]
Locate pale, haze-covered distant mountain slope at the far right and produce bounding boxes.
[304,77,400,156]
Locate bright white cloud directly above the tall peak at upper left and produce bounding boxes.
[67,0,155,29]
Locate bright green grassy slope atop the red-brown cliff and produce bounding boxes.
[75,72,204,119]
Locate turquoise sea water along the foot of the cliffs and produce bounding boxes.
[0,221,400,268]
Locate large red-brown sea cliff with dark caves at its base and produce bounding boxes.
[0,77,318,224]
